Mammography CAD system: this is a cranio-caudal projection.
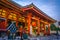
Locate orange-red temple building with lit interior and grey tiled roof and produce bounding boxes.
[0,0,56,36]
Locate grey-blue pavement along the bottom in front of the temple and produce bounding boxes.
[0,35,60,40]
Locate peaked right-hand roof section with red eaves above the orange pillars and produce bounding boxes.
[23,3,56,22]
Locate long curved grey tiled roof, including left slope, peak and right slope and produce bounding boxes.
[0,0,56,22]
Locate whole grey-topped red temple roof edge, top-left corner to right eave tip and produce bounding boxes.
[1,0,56,22]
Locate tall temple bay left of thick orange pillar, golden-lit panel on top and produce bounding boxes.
[18,16,28,39]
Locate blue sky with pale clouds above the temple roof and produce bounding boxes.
[13,0,60,21]
